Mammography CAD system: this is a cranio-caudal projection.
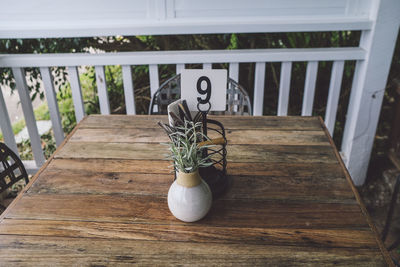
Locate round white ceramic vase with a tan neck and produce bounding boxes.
[168,170,212,222]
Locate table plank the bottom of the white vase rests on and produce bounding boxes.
[5,194,368,229]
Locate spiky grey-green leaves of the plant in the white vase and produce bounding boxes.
[169,120,216,173]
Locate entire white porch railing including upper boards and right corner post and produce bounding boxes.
[0,0,400,185]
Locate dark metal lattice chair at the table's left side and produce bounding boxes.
[0,142,29,214]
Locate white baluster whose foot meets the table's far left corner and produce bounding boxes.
[68,67,85,122]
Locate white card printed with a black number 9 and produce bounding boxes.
[181,69,228,111]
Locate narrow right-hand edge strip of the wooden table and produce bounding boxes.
[318,116,395,267]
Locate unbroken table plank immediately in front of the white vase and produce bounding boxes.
[0,219,376,250]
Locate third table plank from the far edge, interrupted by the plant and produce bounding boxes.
[55,142,336,163]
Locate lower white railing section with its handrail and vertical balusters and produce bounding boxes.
[0,47,372,174]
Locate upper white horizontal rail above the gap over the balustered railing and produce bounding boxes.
[0,15,373,39]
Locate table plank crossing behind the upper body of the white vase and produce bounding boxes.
[28,169,356,204]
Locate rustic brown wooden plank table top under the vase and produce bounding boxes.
[0,115,390,266]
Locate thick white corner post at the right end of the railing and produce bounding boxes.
[342,0,400,185]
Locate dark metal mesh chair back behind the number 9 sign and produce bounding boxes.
[149,74,252,115]
